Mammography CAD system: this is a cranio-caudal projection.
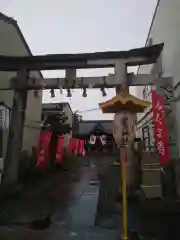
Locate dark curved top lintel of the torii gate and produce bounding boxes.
[0,44,163,71]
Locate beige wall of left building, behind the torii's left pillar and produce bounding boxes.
[0,19,42,155]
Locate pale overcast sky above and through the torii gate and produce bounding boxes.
[0,0,157,119]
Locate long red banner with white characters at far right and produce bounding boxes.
[152,90,169,164]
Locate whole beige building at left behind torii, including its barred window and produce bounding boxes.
[0,13,43,157]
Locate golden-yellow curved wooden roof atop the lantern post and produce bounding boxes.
[99,93,151,113]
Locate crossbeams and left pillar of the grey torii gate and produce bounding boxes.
[0,44,169,187]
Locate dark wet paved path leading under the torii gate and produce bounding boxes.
[0,158,118,240]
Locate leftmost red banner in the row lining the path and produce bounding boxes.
[36,132,52,169]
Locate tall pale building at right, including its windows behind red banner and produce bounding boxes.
[136,0,180,158]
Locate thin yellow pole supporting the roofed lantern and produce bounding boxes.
[121,148,128,240]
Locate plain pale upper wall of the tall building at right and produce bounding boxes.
[137,0,180,156]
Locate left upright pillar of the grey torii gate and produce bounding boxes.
[3,69,29,185]
